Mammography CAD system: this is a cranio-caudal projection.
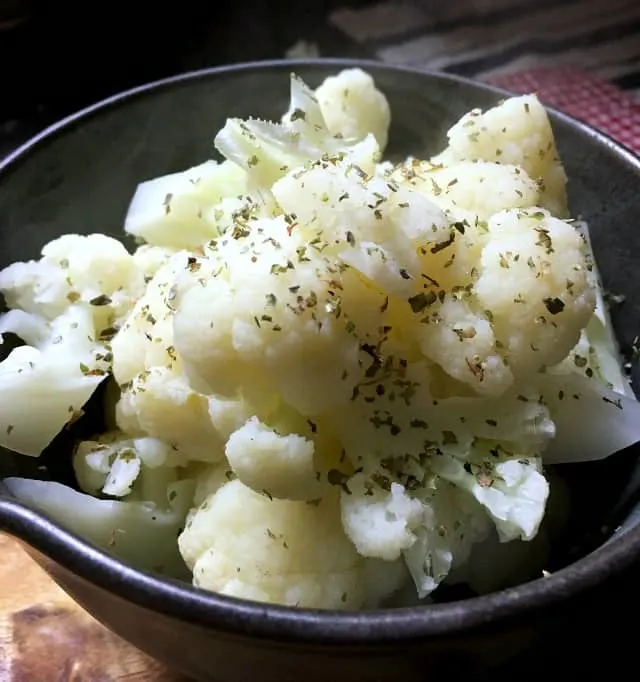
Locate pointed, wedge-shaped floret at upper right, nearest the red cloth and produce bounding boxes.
[433,95,568,218]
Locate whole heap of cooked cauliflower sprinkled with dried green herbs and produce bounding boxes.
[0,69,638,609]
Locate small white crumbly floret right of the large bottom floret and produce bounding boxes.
[340,474,424,561]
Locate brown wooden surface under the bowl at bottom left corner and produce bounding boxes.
[0,534,188,682]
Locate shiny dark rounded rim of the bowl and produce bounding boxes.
[0,58,640,645]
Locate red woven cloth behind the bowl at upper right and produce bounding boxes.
[488,67,640,154]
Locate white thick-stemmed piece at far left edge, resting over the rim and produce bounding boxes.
[0,304,109,457]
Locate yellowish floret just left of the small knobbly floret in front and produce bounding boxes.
[116,367,224,462]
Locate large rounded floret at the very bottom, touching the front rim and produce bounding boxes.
[178,480,365,609]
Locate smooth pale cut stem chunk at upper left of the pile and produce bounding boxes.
[124,161,247,249]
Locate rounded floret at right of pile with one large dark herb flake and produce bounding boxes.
[475,209,595,378]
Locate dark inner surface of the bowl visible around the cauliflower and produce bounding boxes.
[0,62,640,600]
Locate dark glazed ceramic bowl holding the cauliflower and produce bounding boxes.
[0,60,640,682]
